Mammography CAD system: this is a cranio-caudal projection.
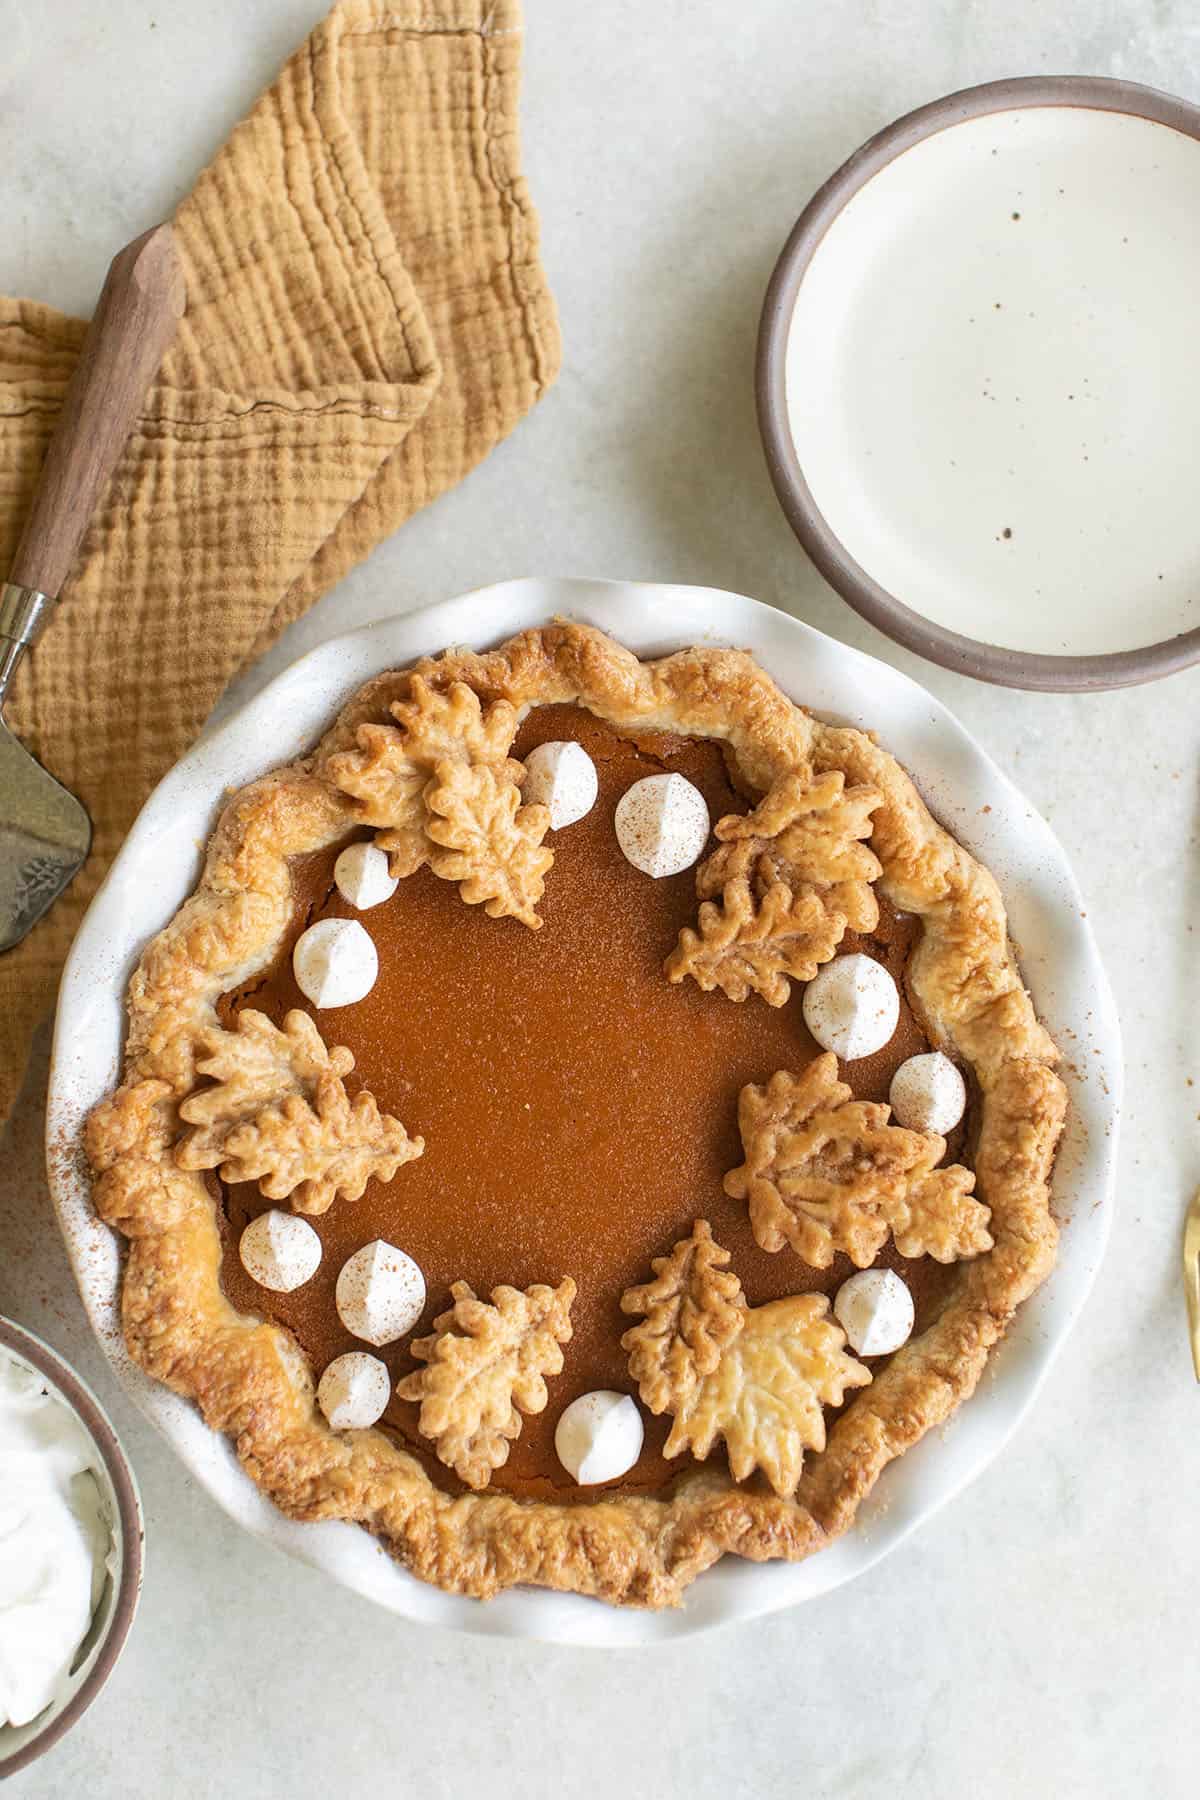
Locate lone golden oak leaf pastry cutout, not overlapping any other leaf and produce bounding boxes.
[396,1276,576,1490]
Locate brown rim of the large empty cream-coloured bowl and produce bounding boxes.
[756,76,1200,693]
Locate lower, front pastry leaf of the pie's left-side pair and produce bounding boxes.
[221,1075,425,1213]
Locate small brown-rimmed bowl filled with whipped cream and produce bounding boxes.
[0,1319,144,1780]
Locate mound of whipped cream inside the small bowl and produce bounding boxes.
[0,1350,113,1724]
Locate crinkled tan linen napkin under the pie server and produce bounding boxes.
[0,0,560,1121]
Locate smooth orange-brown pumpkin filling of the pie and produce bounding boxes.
[210,706,964,1499]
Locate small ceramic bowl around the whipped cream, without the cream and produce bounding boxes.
[0,1319,146,1780]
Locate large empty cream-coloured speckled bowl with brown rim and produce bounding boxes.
[757,77,1200,689]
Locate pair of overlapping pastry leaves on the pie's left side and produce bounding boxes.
[175,1008,425,1213]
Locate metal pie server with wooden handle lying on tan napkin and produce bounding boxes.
[0,225,187,950]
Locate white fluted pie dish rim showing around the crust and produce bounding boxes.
[47,580,1121,1645]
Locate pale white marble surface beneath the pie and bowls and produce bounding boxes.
[0,0,1200,1800]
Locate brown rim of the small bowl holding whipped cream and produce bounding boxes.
[0,1319,146,1780]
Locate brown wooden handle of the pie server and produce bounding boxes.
[9,225,187,598]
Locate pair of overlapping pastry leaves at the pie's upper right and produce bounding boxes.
[666,770,882,1006]
